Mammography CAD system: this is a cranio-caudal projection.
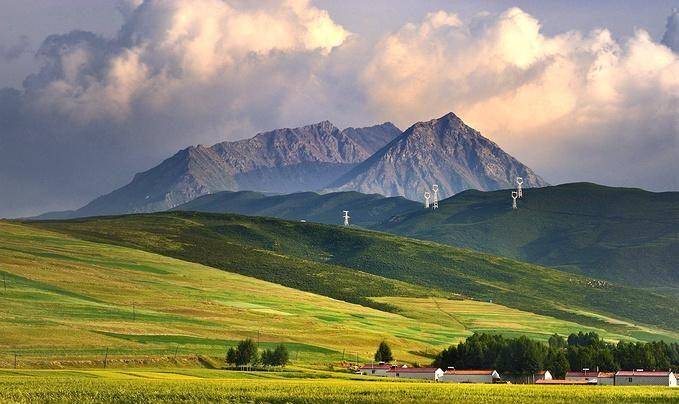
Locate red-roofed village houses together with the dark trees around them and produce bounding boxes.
[355,332,677,387]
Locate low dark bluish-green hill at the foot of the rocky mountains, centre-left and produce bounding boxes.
[172,191,421,227]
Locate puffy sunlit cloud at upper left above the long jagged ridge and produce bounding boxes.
[21,0,349,124]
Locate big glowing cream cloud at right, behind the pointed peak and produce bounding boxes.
[362,8,679,189]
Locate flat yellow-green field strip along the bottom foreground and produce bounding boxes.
[0,370,679,403]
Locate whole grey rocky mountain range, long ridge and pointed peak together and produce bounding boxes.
[39,113,547,219]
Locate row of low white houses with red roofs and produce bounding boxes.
[358,362,677,387]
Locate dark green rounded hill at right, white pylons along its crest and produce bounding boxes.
[376,183,679,287]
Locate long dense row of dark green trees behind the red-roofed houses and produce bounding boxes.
[434,332,679,378]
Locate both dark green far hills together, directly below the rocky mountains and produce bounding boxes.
[170,183,679,288]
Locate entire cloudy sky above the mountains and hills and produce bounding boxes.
[0,0,679,217]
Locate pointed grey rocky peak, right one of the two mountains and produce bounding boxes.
[330,113,546,200]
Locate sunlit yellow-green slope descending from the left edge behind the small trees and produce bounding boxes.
[0,222,644,368]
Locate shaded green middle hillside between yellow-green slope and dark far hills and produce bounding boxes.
[30,212,679,338]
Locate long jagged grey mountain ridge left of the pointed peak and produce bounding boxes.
[70,121,401,217]
